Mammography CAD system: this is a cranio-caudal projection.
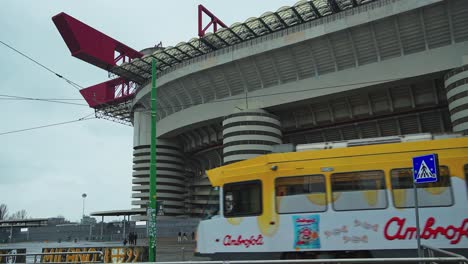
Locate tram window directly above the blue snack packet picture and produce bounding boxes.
[275,175,327,214]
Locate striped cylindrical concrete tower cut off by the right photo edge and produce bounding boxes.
[445,64,468,134]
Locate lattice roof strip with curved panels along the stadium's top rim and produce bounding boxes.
[111,0,376,84]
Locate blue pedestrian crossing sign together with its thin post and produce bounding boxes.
[413,154,439,258]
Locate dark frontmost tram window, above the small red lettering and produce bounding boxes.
[223,181,262,217]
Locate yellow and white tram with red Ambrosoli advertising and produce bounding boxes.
[197,135,468,258]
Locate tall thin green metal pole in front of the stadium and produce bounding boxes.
[148,59,157,262]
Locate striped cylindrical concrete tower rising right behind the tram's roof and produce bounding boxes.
[223,109,282,164]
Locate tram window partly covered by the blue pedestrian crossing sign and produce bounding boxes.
[390,166,453,208]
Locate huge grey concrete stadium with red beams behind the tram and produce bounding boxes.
[54,0,468,220]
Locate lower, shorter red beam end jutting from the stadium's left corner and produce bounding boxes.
[80,78,135,108]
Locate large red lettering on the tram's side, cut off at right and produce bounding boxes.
[384,217,468,245]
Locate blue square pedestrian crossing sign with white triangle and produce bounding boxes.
[413,154,439,183]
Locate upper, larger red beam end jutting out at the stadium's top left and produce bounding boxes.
[52,12,143,70]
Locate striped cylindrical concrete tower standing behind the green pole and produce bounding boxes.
[132,108,186,218]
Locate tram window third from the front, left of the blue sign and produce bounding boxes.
[331,171,388,211]
